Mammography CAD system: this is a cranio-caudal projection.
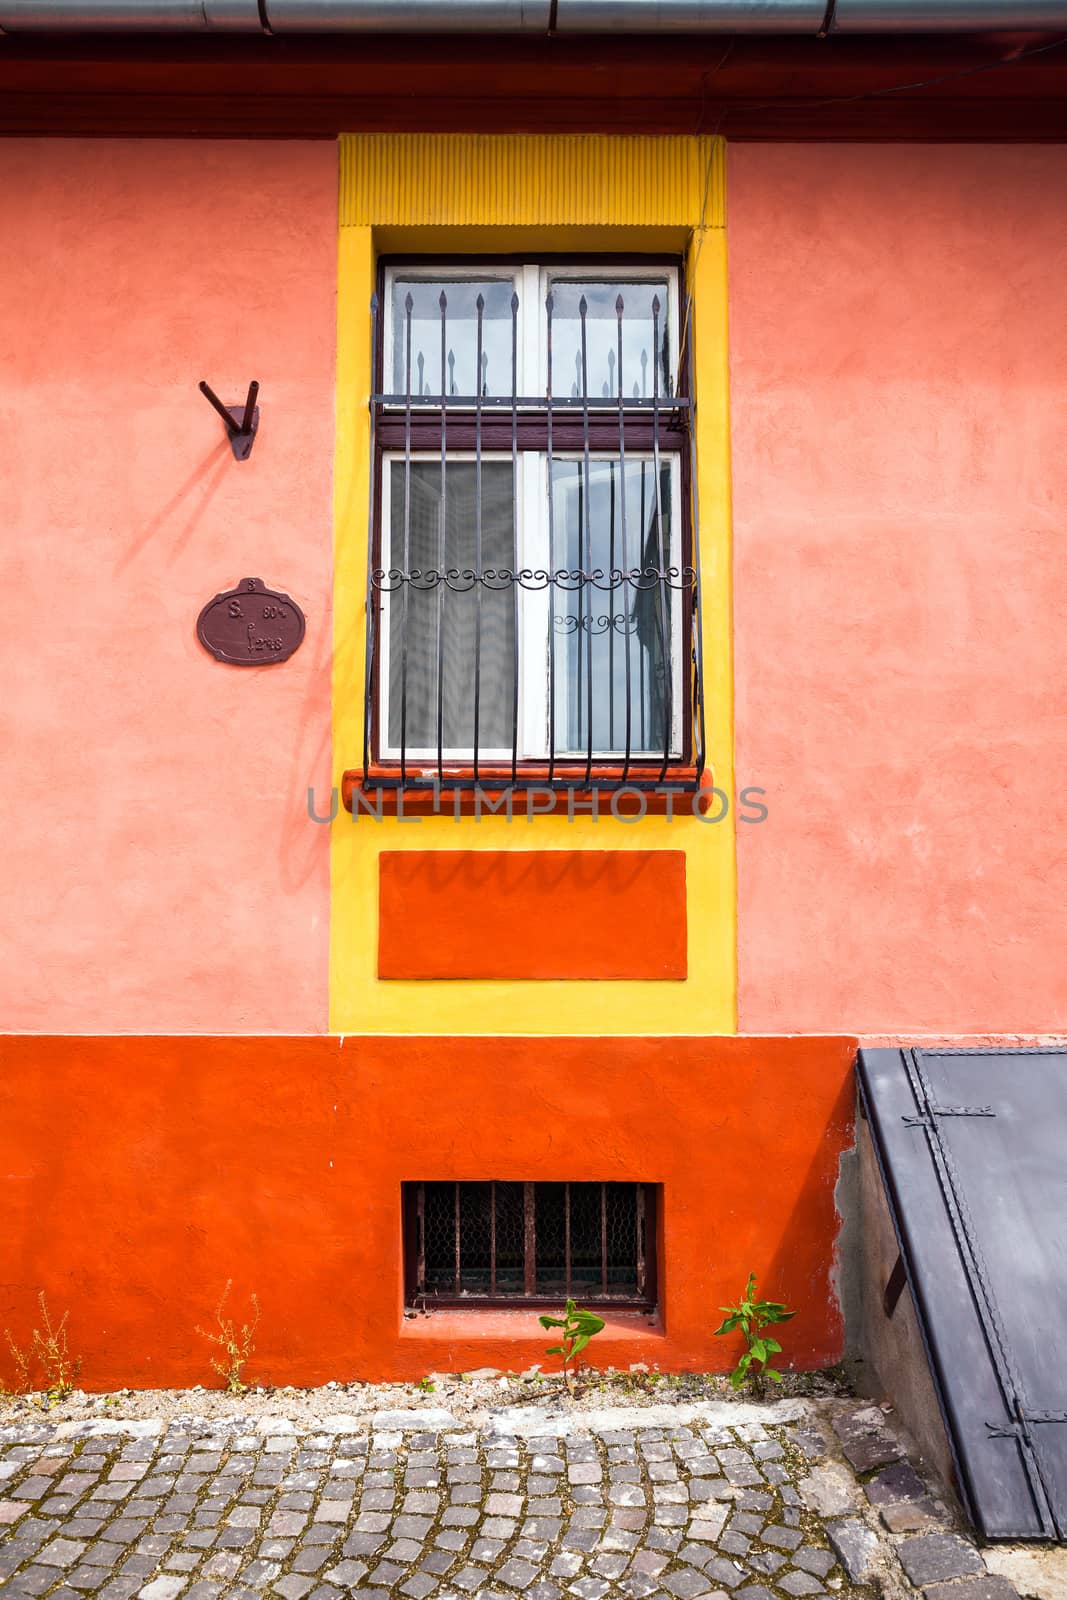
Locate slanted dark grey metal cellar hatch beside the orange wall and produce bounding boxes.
[859,1048,1067,1539]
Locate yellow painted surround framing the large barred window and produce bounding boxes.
[330,134,736,1035]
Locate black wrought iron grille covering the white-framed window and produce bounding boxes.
[363,267,705,792]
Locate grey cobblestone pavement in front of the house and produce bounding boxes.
[0,1402,1014,1600]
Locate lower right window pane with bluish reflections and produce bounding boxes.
[550,458,680,755]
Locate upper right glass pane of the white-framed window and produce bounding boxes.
[547,275,673,400]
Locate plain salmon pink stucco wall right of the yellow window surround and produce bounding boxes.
[728,144,1067,1035]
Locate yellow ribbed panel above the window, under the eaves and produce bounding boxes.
[341,133,726,227]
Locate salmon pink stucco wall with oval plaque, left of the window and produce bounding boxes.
[0,139,338,1034]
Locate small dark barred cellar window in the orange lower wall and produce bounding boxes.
[403,1181,656,1309]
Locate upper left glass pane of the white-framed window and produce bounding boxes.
[392,277,515,400]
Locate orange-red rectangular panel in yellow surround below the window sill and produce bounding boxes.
[378,850,686,979]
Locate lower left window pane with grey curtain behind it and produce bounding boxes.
[382,459,515,752]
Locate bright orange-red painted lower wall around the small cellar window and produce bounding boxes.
[0,1037,854,1389]
